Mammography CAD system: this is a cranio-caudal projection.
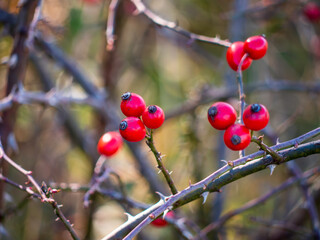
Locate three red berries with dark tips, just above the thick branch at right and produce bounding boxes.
[208,102,269,151]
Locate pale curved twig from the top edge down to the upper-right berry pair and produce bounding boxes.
[131,0,231,47]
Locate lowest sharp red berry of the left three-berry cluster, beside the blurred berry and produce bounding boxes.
[119,117,146,142]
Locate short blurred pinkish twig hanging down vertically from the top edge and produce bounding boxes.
[106,0,119,51]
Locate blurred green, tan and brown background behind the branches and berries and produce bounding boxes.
[0,0,320,240]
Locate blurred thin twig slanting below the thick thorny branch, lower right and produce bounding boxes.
[195,167,320,239]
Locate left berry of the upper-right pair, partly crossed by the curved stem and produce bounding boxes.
[227,42,252,71]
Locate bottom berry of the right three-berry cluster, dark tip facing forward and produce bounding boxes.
[223,123,251,151]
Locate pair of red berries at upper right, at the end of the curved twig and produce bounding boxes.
[226,36,268,71]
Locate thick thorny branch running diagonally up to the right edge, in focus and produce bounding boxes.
[103,128,320,240]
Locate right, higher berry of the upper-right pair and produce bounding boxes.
[244,36,268,60]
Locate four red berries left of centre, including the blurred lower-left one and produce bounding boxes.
[97,92,165,157]
